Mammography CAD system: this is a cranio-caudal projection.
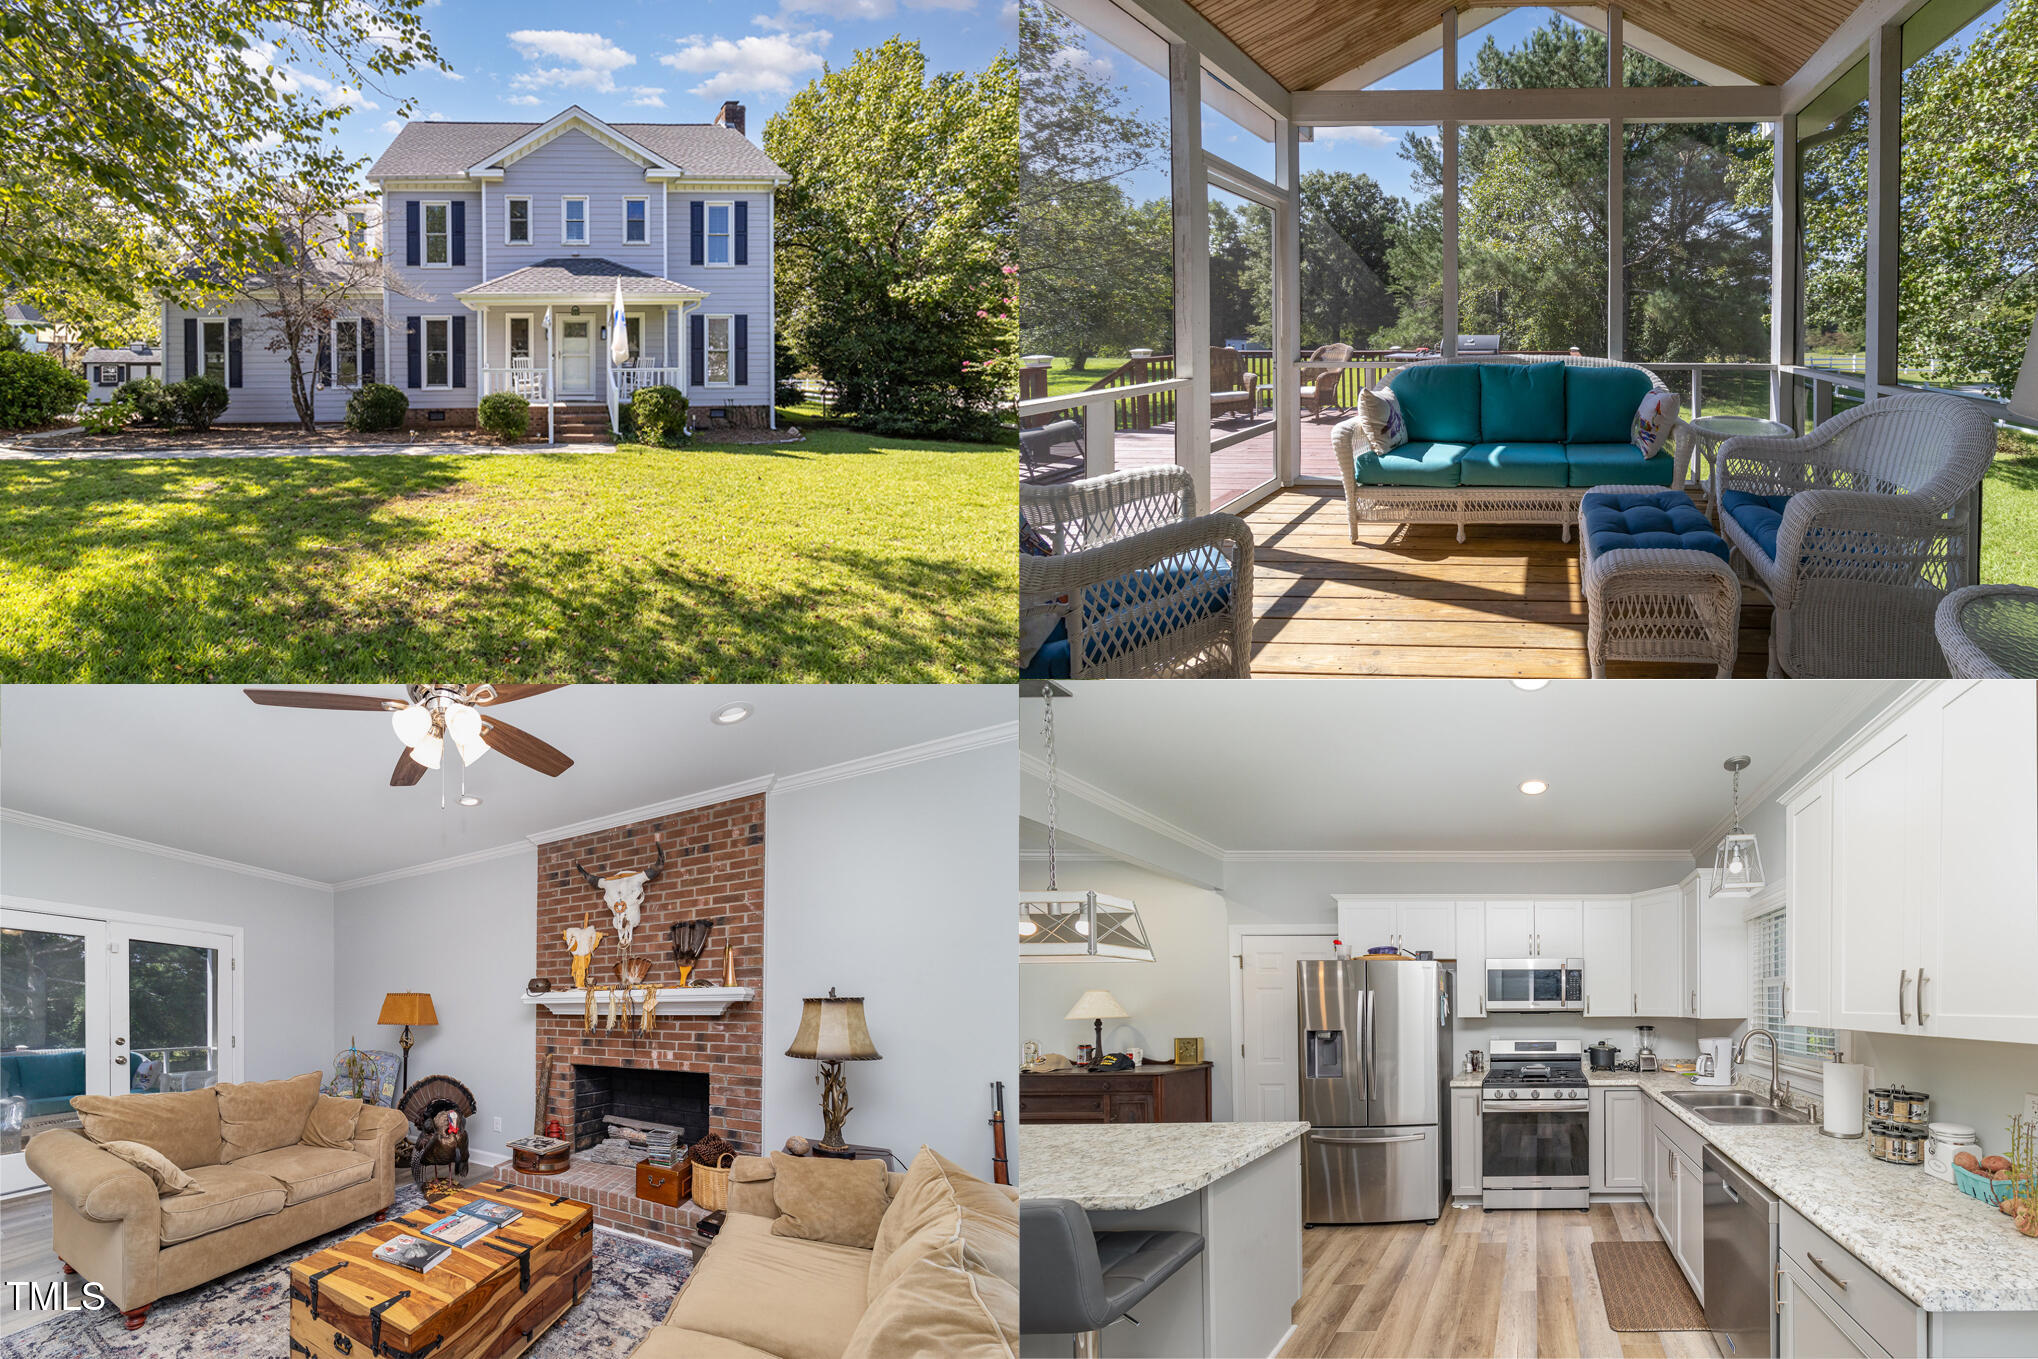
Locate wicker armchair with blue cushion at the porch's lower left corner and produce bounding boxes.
[1019,467,1253,678]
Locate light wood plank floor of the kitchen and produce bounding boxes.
[1282,1202,1720,1359]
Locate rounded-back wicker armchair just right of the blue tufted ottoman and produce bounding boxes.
[1714,393,1995,678]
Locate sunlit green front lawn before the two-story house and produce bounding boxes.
[0,426,1019,683]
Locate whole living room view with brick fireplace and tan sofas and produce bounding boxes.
[0,685,1017,1359]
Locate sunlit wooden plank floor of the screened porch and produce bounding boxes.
[1245,489,1769,678]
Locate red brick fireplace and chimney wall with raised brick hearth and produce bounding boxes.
[499,795,764,1245]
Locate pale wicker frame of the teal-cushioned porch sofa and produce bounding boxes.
[1331,355,1696,542]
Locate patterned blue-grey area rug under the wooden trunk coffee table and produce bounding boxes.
[0,1186,693,1359]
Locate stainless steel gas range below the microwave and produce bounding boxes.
[1480,1039,1592,1212]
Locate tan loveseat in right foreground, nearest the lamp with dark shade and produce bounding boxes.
[632,1147,1019,1359]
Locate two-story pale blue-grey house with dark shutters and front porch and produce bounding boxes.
[163,102,789,436]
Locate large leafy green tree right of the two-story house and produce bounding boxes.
[764,37,1019,438]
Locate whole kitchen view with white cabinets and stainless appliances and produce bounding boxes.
[1017,681,2038,1359]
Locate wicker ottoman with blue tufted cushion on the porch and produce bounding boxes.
[1577,487,1740,678]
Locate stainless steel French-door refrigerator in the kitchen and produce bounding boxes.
[1296,958,1453,1225]
